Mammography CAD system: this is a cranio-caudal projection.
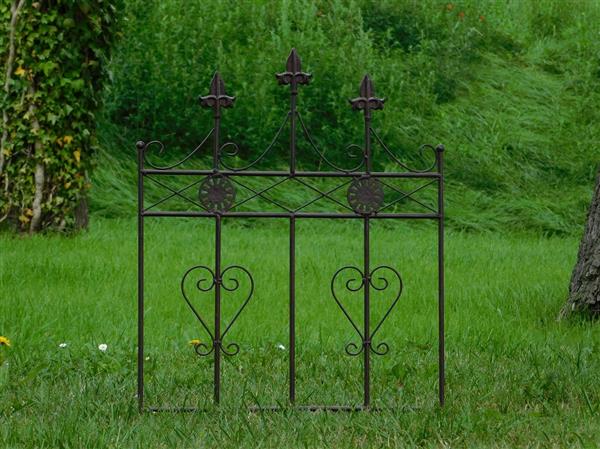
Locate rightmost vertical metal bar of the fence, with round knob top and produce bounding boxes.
[436,145,446,406]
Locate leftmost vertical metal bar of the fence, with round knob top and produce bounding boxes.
[136,141,146,412]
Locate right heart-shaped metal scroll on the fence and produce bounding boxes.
[331,265,403,356]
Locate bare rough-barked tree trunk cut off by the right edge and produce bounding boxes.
[561,166,600,317]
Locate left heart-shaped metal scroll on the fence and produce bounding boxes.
[181,265,254,356]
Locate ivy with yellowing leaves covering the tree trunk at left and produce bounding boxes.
[0,0,121,232]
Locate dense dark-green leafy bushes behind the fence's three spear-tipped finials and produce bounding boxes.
[102,0,488,168]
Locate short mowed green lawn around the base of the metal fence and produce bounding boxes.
[0,218,600,448]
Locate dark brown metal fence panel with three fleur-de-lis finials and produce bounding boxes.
[137,49,445,411]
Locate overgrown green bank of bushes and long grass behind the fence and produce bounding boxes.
[93,0,600,233]
